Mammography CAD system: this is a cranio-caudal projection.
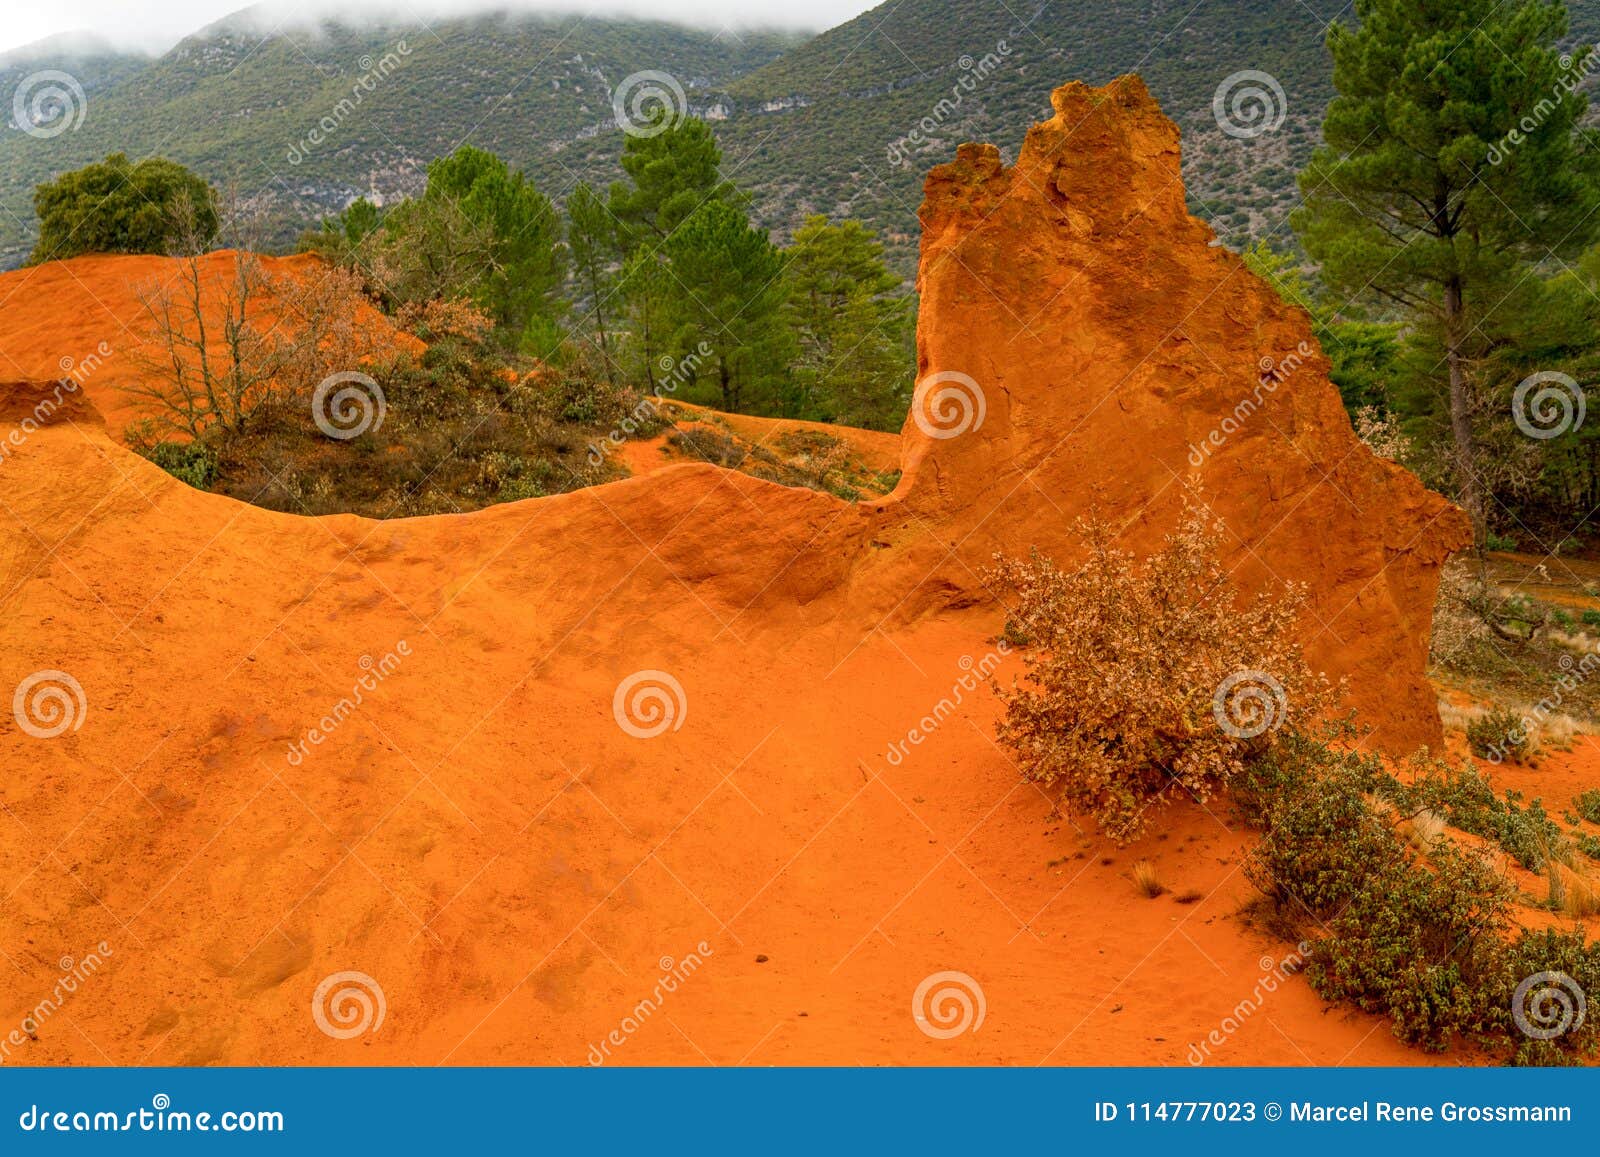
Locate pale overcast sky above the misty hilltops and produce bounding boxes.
[0,0,878,51]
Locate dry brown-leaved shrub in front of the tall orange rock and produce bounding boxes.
[987,509,1336,842]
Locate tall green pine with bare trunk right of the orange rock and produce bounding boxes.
[1293,0,1600,544]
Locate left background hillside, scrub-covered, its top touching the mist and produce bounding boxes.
[0,16,797,266]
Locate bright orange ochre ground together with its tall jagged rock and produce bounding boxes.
[0,80,1561,1064]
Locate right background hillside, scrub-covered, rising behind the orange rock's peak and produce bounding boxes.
[722,0,1600,259]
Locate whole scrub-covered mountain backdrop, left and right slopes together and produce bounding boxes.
[9,0,1600,269]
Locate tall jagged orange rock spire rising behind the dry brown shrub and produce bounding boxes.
[898,77,1469,749]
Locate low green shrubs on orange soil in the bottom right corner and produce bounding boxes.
[1237,735,1600,1064]
